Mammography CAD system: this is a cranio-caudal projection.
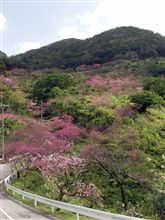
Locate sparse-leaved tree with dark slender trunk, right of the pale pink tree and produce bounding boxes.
[82,143,151,210]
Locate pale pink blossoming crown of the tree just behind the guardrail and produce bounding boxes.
[32,153,86,190]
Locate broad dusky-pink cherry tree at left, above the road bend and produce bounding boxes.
[5,120,70,175]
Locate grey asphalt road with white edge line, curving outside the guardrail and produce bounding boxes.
[0,164,55,220]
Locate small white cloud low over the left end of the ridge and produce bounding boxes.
[14,41,42,53]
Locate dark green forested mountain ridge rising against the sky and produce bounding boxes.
[10,26,165,69]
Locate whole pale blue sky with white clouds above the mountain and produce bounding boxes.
[0,0,165,56]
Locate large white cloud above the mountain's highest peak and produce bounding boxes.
[59,0,165,39]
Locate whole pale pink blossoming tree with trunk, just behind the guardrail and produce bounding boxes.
[33,154,101,201]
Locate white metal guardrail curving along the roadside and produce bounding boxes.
[0,172,144,220]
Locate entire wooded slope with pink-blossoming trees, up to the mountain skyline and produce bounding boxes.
[0,27,165,220]
